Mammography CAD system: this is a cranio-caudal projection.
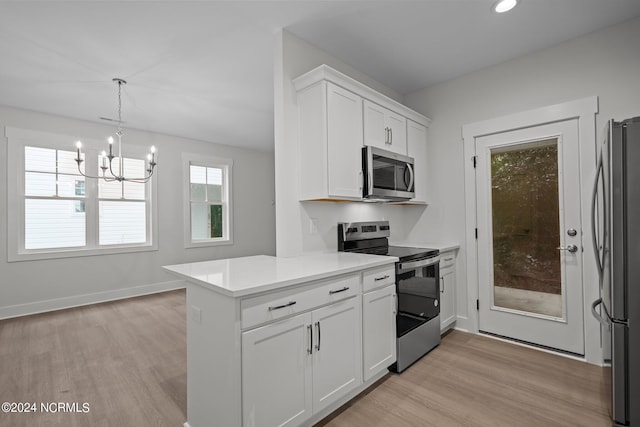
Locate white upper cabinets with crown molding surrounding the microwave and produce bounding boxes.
[293,65,430,203]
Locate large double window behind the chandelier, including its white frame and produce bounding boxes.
[6,128,157,261]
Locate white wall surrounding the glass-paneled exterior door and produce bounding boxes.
[405,19,640,360]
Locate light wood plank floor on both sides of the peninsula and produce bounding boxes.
[0,290,611,427]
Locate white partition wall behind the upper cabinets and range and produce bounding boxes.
[274,31,427,256]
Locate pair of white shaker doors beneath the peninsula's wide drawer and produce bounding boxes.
[242,297,362,426]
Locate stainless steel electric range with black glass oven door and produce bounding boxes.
[338,221,440,372]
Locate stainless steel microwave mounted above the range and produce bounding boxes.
[362,145,415,201]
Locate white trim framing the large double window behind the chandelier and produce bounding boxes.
[5,126,158,262]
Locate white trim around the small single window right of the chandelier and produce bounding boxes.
[182,153,233,248]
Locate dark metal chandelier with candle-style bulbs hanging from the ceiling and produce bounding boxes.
[75,78,156,183]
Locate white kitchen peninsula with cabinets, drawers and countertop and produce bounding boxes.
[164,252,397,427]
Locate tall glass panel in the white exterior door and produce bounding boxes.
[491,138,563,317]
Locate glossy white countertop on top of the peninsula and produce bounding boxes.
[163,252,398,297]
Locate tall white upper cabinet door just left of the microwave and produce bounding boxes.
[327,83,363,198]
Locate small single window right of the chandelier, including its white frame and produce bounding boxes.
[184,154,233,248]
